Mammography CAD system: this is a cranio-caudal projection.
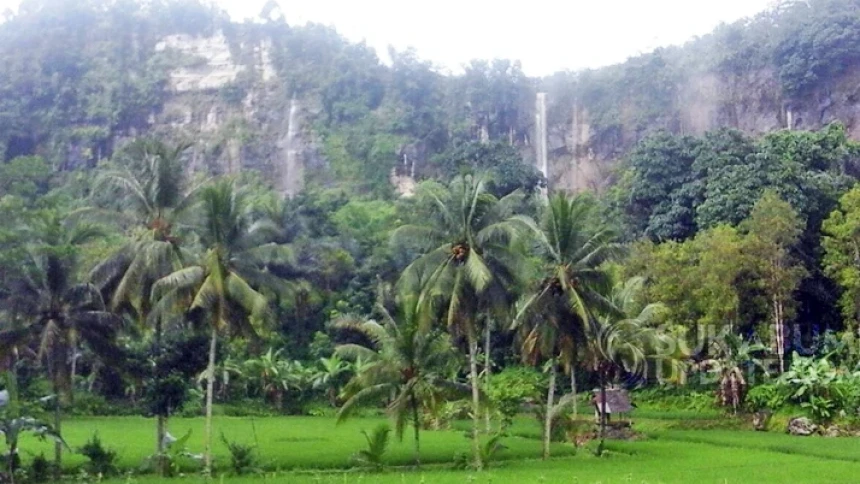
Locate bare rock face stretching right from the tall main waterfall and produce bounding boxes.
[548,67,860,195]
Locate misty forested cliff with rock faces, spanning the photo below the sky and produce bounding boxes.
[5,0,860,195]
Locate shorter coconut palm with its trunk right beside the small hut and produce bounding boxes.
[586,277,679,450]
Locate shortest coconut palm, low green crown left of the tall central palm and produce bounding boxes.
[335,295,467,465]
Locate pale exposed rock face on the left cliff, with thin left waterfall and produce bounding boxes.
[149,32,318,196]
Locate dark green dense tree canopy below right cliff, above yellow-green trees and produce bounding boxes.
[617,123,854,246]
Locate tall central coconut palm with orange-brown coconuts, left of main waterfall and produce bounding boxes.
[393,175,527,469]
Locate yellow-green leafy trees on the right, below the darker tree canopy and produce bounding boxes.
[624,191,808,347]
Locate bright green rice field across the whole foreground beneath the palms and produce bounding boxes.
[16,414,860,484]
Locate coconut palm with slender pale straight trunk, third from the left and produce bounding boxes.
[152,179,281,473]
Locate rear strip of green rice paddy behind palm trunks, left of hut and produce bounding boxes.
[15,417,573,470]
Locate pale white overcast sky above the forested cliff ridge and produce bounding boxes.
[0,0,774,76]
